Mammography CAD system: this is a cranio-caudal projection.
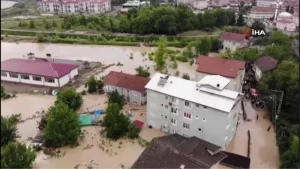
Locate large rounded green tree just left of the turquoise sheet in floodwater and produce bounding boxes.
[44,102,81,147]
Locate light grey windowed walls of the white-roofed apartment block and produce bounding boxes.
[147,90,238,147]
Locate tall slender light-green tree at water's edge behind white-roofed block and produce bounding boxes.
[154,38,167,71]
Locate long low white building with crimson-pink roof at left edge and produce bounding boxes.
[1,59,79,88]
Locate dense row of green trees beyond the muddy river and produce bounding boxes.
[55,5,236,34]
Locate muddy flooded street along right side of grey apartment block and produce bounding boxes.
[226,102,280,169]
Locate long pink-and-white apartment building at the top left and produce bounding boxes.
[38,0,111,14]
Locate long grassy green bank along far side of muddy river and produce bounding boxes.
[1,29,217,48]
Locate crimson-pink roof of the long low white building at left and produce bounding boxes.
[1,59,79,78]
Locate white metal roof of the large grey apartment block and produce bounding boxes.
[146,73,239,112]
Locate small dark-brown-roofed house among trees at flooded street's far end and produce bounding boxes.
[253,56,278,81]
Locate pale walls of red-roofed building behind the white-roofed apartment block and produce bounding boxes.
[196,70,245,92]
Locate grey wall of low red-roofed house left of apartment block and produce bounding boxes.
[103,85,147,105]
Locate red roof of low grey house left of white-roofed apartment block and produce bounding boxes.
[104,71,150,92]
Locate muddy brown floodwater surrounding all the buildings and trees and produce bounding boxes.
[1,42,279,169]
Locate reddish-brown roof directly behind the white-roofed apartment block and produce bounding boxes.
[196,56,245,78]
